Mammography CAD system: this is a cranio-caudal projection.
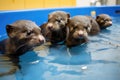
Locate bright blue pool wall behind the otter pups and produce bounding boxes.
[0,6,120,37]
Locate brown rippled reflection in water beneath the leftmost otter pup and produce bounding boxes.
[0,55,21,77]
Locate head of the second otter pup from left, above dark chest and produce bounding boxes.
[47,11,70,31]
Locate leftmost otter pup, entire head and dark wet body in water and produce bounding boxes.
[0,20,45,76]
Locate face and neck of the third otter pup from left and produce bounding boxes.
[66,16,88,47]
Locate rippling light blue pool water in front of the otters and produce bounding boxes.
[0,17,120,80]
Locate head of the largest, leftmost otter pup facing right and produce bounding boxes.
[6,20,45,55]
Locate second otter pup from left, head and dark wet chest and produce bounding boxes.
[40,11,70,44]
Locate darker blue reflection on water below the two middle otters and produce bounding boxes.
[50,44,91,65]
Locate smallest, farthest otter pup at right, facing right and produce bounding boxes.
[96,14,112,29]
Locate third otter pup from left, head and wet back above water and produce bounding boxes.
[66,15,100,47]
